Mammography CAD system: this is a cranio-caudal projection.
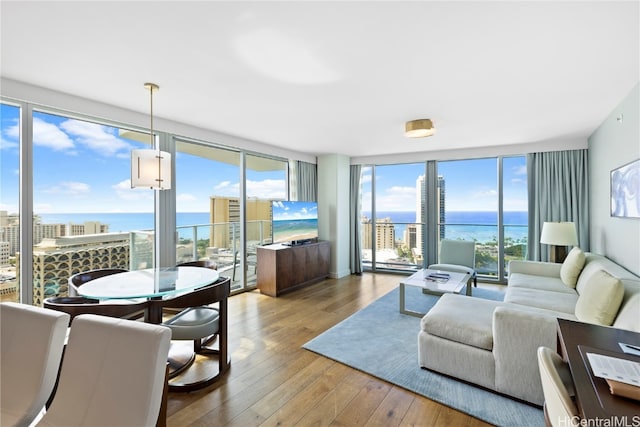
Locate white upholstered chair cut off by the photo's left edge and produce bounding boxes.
[0,302,69,426]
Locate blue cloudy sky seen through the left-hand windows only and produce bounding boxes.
[0,105,287,214]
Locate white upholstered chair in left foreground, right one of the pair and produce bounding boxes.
[37,314,171,426]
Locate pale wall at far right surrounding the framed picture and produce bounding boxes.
[589,84,640,274]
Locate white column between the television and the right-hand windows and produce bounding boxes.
[318,154,351,279]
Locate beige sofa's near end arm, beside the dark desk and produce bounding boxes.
[493,306,558,405]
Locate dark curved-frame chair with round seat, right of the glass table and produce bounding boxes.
[149,277,231,392]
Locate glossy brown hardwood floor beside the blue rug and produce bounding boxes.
[167,273,496,427]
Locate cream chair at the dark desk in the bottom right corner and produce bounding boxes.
[538,347,580,427]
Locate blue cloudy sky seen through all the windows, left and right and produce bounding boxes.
[0,104,527,214]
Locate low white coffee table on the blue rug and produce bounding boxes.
[400,269,471,317]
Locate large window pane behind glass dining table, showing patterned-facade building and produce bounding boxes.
[32,111,154,305]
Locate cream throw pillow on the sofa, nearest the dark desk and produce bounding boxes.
[575,270,624,326]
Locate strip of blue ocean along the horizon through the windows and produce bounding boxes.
[39,211,527,243]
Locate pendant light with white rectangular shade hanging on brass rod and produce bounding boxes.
[131,83,171,190]
